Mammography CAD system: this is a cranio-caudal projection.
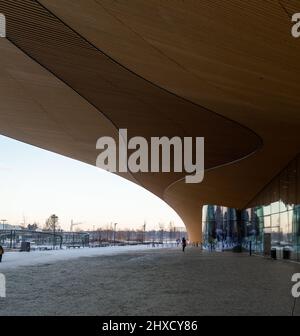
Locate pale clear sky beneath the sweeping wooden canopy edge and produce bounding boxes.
[0,135,184,230]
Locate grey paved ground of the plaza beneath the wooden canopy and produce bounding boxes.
[0,248,300,315]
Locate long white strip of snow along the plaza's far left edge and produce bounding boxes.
[0,245,162,272]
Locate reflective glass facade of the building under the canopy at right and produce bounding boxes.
[202,156,300,260]
